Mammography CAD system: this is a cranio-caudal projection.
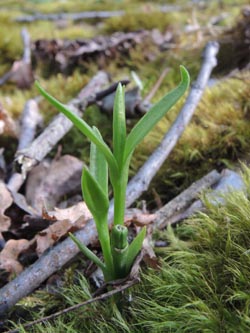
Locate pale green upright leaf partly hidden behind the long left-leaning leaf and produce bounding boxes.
[89,127,108,197]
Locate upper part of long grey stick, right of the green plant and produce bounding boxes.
[126,42,219,207]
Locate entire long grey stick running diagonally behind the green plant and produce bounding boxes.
[0,42,219,316]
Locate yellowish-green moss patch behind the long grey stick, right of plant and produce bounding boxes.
[132,74,250,204]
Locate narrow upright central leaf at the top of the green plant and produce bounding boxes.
[113,83,127,166]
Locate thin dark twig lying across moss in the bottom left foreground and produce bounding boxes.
[5,279,139,333]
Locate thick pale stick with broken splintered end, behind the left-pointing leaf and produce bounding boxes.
[16,71,108,178]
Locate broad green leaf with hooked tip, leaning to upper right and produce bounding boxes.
[124,66,190,160]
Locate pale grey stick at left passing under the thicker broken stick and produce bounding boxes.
[8,99,42,192]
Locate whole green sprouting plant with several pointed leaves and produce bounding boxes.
[36,66,189,281]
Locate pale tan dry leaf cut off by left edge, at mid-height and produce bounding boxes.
[0,181,13,232]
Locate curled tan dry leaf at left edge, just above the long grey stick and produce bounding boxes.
[0,239,30,274]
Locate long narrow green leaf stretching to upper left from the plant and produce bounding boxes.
[35,81,118,174]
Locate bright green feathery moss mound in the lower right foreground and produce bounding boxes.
[10,168,250,333]
